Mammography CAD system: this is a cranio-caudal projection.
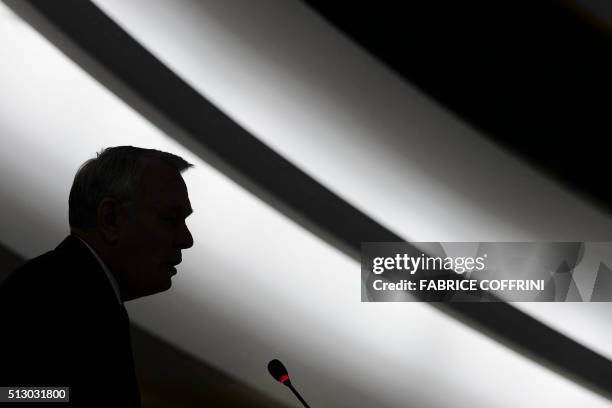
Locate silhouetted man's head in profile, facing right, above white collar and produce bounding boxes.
[68,146,193,300]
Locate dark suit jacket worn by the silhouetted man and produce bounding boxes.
[0,236,140,407]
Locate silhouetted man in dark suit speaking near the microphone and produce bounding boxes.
[0,146,193,407]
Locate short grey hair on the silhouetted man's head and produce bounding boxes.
[68,146,193,229]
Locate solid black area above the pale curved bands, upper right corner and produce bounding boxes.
[304,0,612,213]
